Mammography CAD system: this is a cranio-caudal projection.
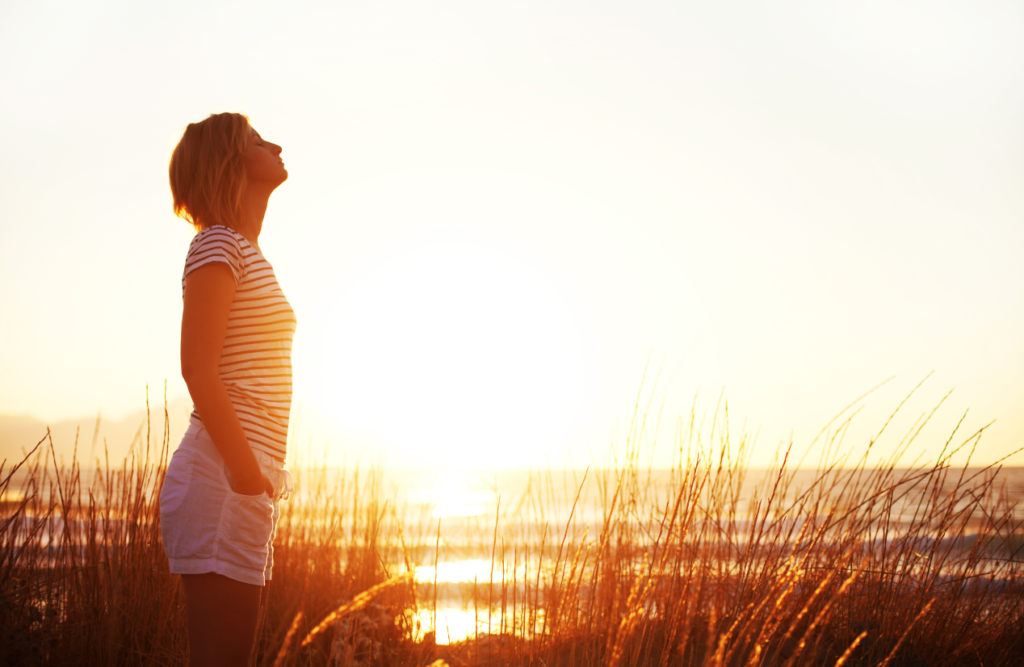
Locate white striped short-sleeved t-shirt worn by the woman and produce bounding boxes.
[181,225,296,461]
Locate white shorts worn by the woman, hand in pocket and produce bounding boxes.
[160,424,292,586]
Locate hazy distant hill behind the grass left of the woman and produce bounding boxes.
[0,399,191,467]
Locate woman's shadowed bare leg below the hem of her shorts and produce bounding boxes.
[181,572,264,667]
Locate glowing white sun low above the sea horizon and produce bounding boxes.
[297,241,586,468]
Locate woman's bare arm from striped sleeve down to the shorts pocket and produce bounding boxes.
[181,262,273,496]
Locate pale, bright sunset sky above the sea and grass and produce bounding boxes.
[0,0,1024,468]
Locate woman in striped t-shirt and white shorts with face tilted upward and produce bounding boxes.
[160,114,295,667]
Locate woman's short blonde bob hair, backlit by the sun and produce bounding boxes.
[168,114,249,231]
